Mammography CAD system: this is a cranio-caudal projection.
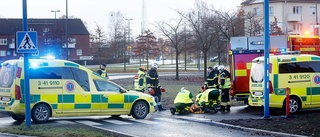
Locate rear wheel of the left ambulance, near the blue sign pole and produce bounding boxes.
[31,104,51,123]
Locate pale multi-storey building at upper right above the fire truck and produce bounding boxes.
[241,0,320,35]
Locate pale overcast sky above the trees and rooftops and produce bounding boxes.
[0,0,242,35]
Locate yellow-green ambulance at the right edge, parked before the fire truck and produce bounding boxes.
[248,54,320,113]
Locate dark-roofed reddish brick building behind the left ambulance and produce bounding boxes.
[0,18,91,62]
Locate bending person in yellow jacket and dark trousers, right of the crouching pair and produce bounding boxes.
[199,85,219,112]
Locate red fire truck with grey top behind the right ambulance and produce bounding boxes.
[228,35,320,103]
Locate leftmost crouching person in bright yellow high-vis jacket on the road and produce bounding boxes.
[170,87,193,115]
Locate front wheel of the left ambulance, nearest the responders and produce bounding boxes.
[131,101,149,119]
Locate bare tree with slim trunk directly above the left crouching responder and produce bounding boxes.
[155,16,185,80]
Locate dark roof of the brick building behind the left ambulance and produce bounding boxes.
[0,18,89,35]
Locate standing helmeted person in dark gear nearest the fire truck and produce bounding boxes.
[219,65,231,111]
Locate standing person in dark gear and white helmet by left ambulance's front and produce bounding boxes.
[147,63,166,111]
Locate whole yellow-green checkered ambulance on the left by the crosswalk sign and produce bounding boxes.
[0,58,156,123]
